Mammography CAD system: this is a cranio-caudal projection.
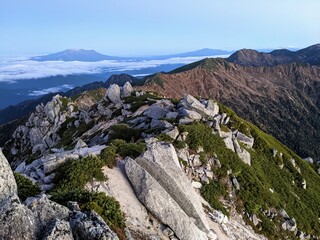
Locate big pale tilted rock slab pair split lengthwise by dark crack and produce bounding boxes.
[125,142,214,239]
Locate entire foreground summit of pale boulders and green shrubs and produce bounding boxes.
[0,82,320,240]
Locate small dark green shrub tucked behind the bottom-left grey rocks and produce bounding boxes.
[13,172,41,201]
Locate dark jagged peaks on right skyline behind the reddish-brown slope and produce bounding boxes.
[227,44,320,67]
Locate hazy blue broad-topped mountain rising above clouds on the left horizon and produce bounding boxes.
[31,49,124,62]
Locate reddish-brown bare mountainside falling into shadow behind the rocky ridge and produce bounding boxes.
[140,59,320,161]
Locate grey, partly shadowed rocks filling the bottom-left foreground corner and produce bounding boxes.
[0,150,118,240]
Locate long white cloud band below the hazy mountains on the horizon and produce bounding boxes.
[0,55,230,82]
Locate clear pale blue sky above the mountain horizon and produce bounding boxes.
[0,0,320,56]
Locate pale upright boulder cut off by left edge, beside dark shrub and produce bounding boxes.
[0,148,18,205]
